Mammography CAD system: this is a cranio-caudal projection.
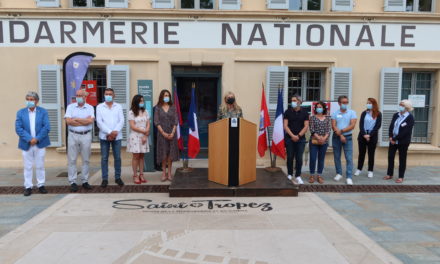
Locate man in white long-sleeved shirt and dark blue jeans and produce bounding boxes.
[96,88,125,188]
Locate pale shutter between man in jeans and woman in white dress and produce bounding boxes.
[107,65,130,146]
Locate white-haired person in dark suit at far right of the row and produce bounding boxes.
[384,100,414,183]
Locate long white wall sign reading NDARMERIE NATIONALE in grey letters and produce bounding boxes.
[0,19,440,51]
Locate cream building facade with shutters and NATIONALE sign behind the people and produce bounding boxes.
[0,0,440,167]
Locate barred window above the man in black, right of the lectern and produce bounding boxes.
[287,69,324,102]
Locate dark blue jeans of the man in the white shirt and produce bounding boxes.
[100,139,121,180]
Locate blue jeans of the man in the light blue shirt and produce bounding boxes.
[332,136,353,179]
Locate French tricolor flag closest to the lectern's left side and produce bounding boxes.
[188,88,200,159]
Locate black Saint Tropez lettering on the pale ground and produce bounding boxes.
[113,198,273,213]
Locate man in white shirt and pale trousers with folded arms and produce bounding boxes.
[64,90,95,192]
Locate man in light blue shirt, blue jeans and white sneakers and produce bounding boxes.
[332,95,357,185]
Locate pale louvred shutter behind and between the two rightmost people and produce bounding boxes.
[379,68,402,146]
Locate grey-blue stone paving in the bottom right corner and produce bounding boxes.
[318,193,440,264]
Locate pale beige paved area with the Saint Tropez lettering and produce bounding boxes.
[0,193,401,264]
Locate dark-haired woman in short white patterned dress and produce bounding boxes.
[127,94,150,184]
